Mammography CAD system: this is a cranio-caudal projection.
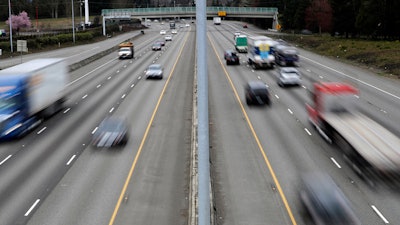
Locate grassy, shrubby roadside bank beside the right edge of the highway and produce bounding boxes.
[277,34,400,78]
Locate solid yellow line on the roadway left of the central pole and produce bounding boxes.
[108,32,190,225]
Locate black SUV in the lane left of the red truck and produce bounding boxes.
[245,80,271,105]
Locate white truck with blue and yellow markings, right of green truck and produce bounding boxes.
[247,36,277,69]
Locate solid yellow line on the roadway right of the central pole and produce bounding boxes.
[208,33,297,225]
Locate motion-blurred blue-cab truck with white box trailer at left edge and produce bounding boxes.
[0,58,68,140]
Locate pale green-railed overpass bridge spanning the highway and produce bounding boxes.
[101,7,278,35]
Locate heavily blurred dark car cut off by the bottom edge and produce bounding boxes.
[300,172,361,225]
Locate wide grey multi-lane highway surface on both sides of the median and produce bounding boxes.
[0,21,400,225]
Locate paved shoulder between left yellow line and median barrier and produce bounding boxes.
[113,26,195,224]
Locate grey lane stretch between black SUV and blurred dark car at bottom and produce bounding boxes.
[249,92,382,224]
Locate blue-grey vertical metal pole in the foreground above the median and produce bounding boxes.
[196,0,211,225]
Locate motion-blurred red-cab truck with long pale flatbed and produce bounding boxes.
[306,82,400,178]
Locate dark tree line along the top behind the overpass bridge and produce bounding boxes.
[0,0,400,40]
